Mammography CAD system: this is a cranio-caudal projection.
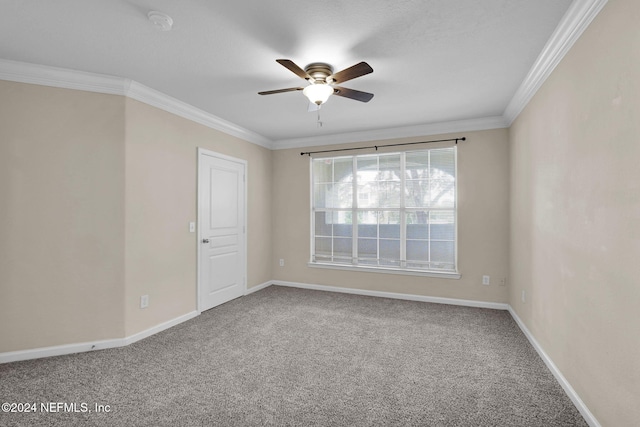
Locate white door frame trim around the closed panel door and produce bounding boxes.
[196,147,249,314]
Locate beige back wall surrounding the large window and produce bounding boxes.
[272,129,509,303]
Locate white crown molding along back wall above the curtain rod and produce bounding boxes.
[273,116,508,150]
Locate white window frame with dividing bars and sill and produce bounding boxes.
[308,146,461,279]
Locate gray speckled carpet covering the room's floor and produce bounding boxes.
[0,286,587,427]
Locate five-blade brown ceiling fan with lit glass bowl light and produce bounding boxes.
[258,59,373,107]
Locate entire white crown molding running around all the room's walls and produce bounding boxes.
[0,0,608,154]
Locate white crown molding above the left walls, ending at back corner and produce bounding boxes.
[0,59,272,149]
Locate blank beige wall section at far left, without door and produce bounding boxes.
[0,81,124,352]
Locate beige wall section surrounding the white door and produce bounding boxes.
[125,99,272,336]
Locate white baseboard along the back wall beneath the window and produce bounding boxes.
[271,280,509,310]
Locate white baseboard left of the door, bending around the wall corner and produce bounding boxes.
[0,311,198,364]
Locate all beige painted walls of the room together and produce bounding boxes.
[0,0,640,426]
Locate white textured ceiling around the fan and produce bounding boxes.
[0,0,568,145]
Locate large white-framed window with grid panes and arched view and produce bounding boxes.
[311,147,457,274]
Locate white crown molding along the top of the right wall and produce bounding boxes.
[503,0,608,126]
